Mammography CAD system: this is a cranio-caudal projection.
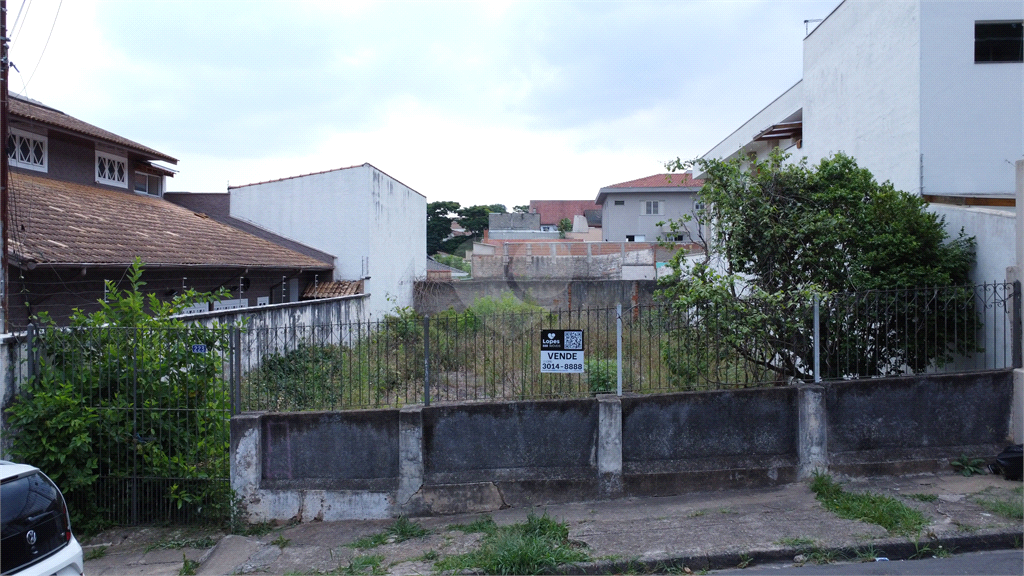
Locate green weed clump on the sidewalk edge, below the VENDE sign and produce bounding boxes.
[434,513,590,574]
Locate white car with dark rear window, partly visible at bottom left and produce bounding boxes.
[0,460,84,576]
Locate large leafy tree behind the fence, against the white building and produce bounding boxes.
[660,151,976,384]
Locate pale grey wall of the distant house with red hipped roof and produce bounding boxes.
[601,191,696,242]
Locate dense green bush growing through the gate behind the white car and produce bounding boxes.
[7,259,230,532]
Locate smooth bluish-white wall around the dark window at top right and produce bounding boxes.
[921,1,1024,196]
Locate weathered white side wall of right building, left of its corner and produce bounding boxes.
[802,0,921,193]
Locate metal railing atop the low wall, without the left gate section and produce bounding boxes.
[237,283,1021,411]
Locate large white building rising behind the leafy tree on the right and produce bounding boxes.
[697,0,1024,283]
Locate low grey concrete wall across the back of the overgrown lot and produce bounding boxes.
[416,279,657,315]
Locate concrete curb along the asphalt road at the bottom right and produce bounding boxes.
[553,531,1024,576]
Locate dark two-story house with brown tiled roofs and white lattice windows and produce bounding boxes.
[4,94,334,331]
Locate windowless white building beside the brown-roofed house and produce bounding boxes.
[228,164,427,318]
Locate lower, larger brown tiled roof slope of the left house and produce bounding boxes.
[8,173,332,270]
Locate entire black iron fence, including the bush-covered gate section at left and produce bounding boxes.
[8,283,1022,525]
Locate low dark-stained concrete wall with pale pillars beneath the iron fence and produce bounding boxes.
[231,370,1013,522]
